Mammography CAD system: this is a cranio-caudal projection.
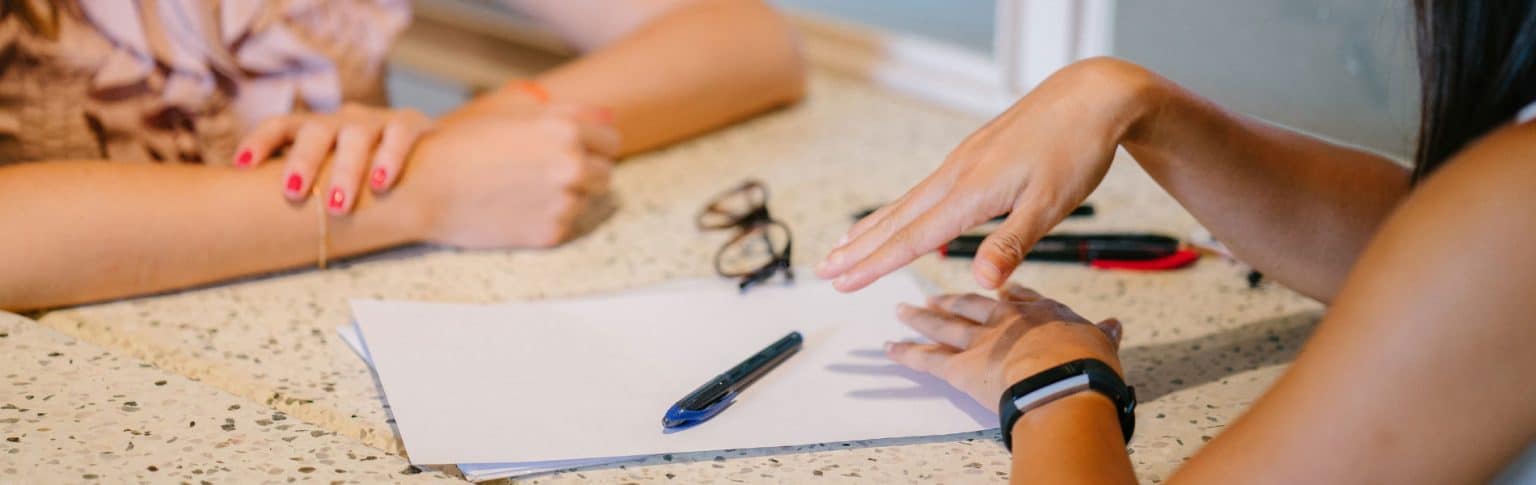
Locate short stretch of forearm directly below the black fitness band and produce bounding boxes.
[1012,393,1137,483]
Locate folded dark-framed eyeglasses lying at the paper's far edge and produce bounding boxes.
[697,180,794,292]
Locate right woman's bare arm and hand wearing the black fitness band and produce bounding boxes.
[888,124,1536,483]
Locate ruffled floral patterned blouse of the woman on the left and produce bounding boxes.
[0,0,410,164]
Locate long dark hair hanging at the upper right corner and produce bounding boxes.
[1413,0,1536,180]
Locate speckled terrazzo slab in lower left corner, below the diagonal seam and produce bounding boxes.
[0,313,455,483]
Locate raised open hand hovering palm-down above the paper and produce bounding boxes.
[816,58,1149,292]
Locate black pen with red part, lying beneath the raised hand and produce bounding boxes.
[938,233,1200,270]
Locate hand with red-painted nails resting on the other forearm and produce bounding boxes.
[235,103,433,215]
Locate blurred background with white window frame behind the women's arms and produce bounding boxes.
[390,0,1418,158]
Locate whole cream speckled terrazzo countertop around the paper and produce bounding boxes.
[0,74,1321,483]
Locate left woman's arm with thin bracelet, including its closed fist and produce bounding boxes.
[0,115,617,310]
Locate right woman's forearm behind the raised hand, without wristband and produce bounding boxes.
[1120,60,1410,301]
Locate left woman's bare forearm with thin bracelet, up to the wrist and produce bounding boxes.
[0,161,421,310]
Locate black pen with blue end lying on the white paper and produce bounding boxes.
[662,332,803,430]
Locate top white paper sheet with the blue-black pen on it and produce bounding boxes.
[353,276,995,465]
